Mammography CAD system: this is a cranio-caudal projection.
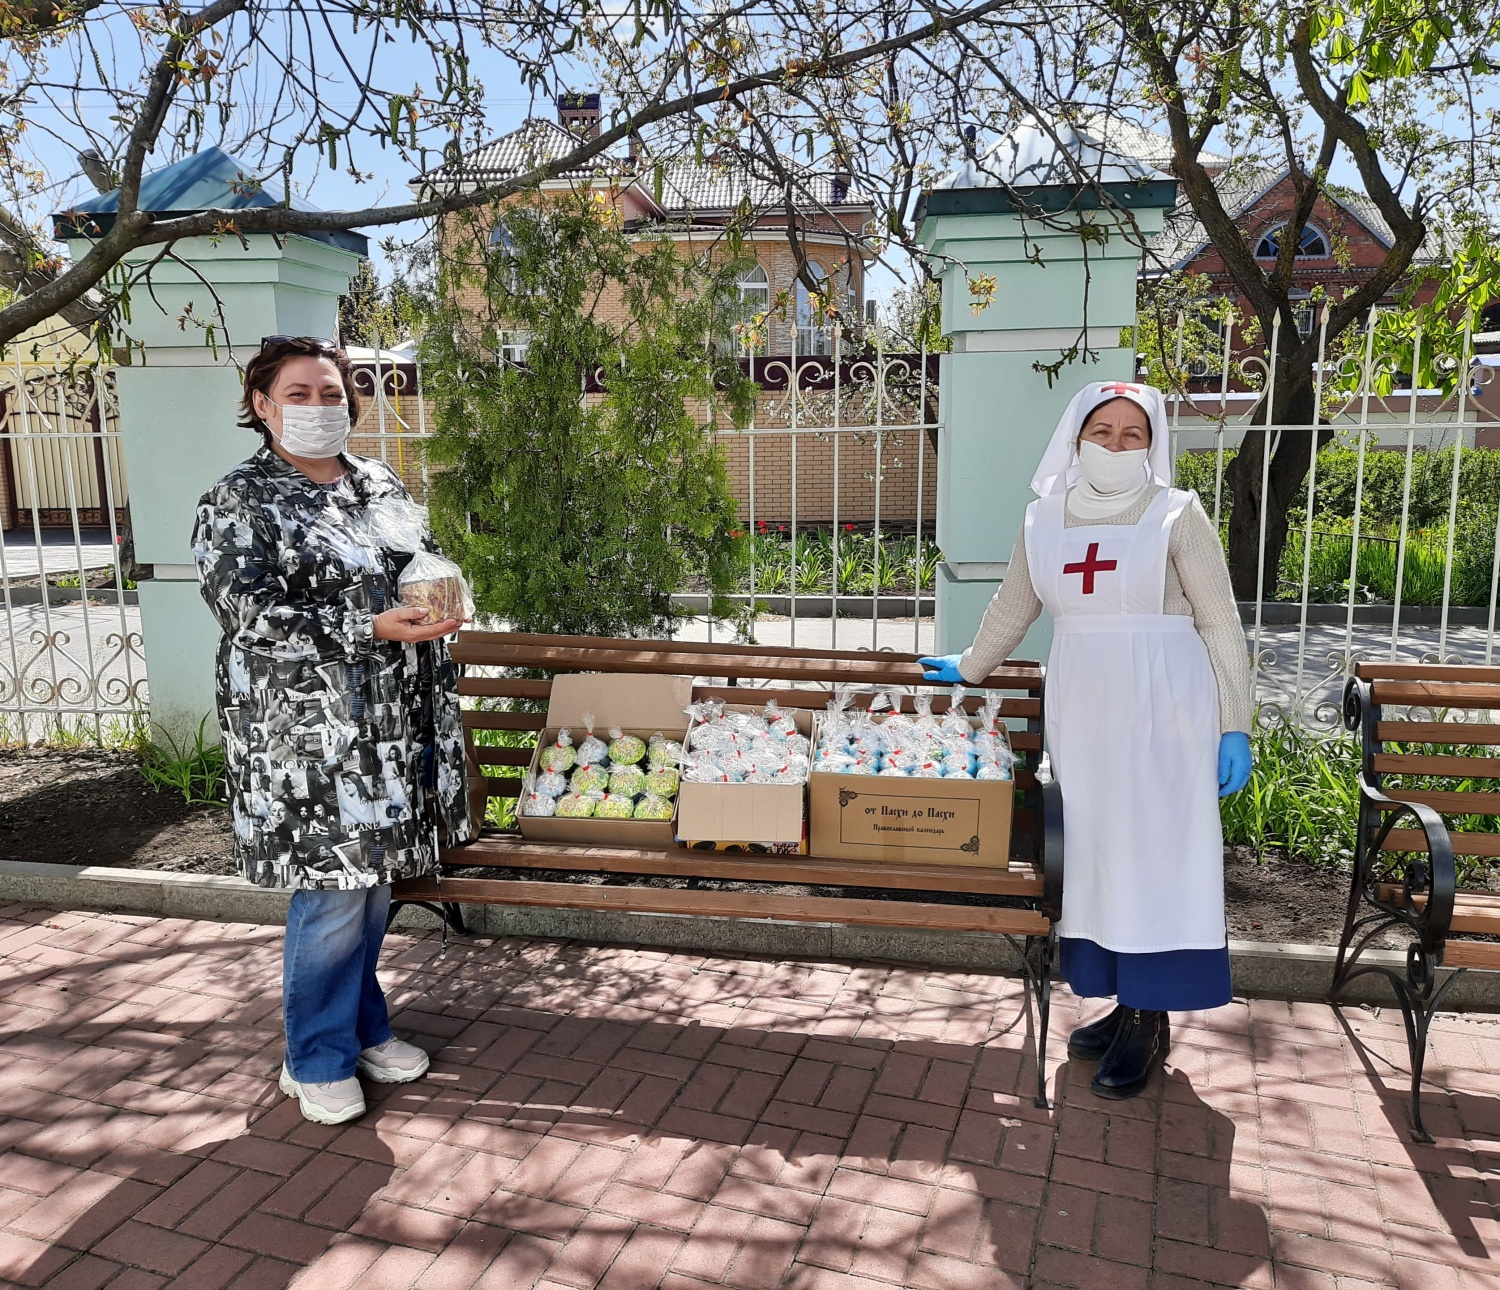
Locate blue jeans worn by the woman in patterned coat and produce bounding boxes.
[282,884,390,1085]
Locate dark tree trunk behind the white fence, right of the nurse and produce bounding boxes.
[1224,360,1332,602]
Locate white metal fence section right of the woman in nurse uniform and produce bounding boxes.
[1169,312,1500,731]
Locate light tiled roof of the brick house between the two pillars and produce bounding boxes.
[419,117,869,218]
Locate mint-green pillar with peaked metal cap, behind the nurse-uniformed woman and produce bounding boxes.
[918,120,1176,659]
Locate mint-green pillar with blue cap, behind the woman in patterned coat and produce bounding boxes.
[54,149,366,740]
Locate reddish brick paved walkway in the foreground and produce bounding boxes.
[0,906,1500,1290]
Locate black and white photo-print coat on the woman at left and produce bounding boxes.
[194,449,470,888]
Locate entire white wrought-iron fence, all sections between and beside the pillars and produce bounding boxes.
[0,310,1500,740]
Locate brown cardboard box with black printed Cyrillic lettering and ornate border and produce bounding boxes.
[807,722,1016,867]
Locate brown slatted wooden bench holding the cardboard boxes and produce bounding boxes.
[393,632,1062,1106]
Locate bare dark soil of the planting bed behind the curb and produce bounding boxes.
[0,749,1488,945]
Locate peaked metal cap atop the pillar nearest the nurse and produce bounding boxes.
[917,116,1178,225]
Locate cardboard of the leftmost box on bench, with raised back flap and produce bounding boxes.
[516,672,693,849]
